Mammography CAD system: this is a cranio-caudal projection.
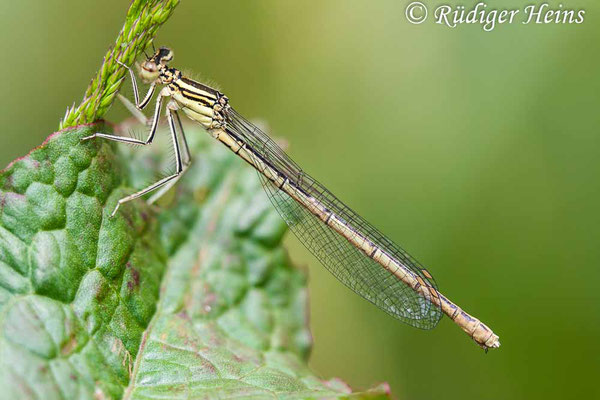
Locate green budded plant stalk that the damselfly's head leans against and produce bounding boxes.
[60,0,179,129]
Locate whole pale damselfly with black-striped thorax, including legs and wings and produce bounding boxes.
[83,47,500,350]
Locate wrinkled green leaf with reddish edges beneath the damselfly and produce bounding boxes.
[0,124,387,399]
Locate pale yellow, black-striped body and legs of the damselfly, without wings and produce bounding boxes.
[113,48,500,349]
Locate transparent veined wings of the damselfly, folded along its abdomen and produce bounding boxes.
[227,109,442,329]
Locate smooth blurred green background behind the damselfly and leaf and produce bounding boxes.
[0,0,600,399]
